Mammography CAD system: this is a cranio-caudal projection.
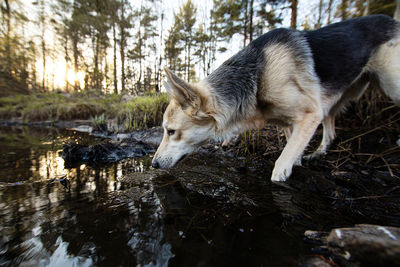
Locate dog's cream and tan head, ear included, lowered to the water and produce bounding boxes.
[152,69,215,169]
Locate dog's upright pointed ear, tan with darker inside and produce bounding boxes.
[164,67,201,110]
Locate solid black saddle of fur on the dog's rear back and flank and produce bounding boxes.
[305,15,400,94]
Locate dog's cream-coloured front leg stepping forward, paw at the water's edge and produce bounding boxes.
[271,112,322,182]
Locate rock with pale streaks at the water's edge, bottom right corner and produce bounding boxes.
[303,224,400,266]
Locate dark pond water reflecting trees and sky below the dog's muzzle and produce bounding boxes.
[0,128,396,266]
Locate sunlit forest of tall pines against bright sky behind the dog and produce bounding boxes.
[0,0,396,96]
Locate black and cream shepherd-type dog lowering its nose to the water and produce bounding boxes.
[152,15,400,182]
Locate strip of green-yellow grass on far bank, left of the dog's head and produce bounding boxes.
[0,93,169,131]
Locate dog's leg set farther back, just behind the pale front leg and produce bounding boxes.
[304,115,336,160]
